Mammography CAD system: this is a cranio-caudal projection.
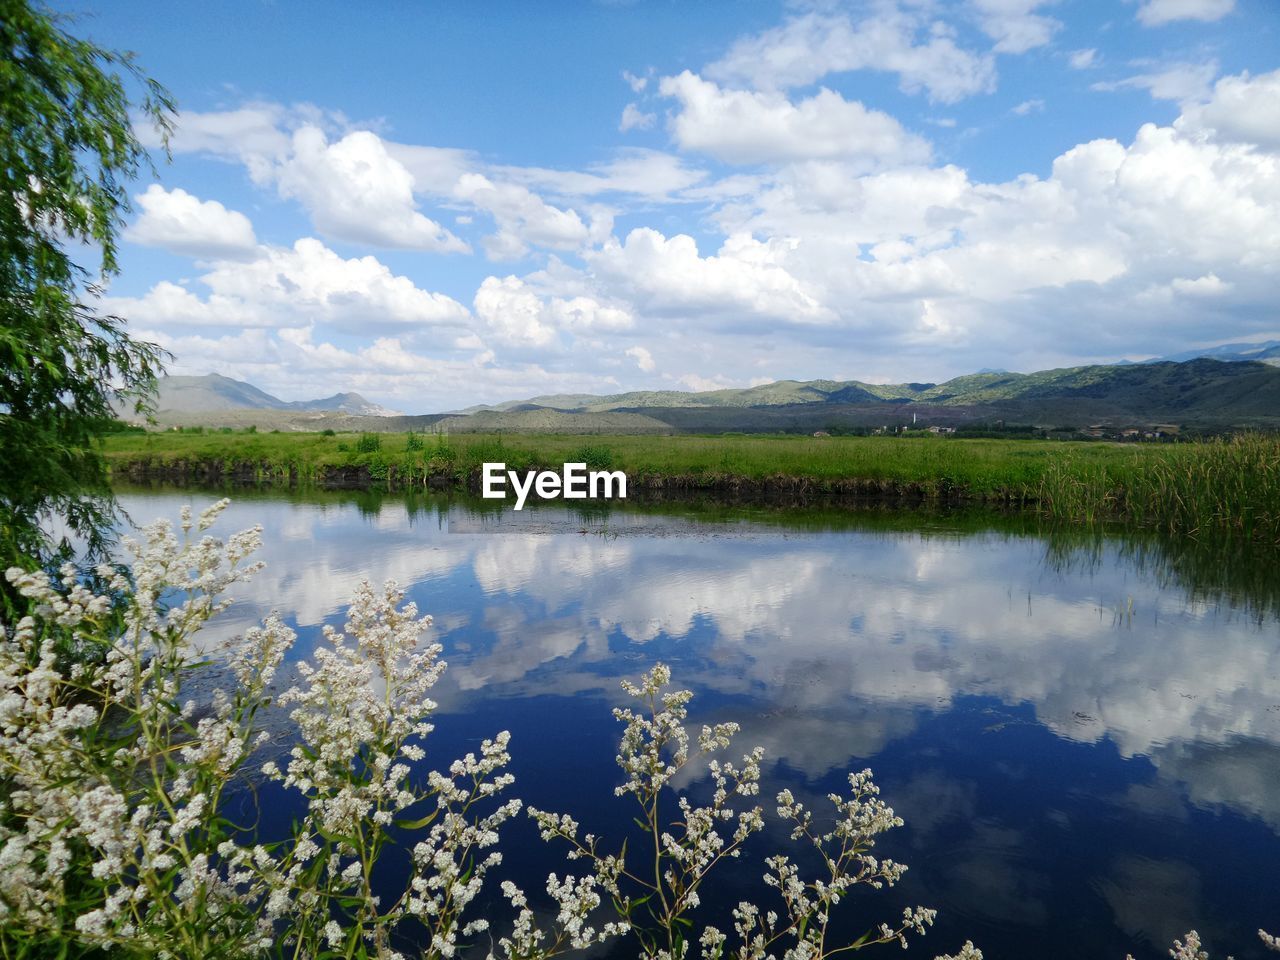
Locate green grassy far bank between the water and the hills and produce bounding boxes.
[106,433,1280,540]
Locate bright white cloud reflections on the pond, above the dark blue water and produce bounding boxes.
[117,495,1280,823]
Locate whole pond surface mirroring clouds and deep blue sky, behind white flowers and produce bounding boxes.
[124,494,1280,960]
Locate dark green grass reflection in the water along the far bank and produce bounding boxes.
[118,485,1280,621]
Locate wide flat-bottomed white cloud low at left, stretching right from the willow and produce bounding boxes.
[109,238,468,334]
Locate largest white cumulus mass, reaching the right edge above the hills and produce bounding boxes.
[680,76,1280,366]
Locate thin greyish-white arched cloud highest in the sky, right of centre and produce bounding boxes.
[705,4,996,104]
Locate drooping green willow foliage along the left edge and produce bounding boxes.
[0,0,173,566]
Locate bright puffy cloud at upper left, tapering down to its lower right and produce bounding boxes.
[274,127,468,253]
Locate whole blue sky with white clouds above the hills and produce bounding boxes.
[51,0,1280,413]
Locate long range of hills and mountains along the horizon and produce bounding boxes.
[137,340,1280,433]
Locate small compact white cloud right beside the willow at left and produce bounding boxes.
[124,183,257,259]
